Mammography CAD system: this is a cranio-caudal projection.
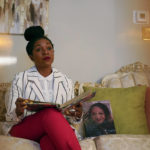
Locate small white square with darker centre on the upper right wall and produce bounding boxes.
[133,10,149,24]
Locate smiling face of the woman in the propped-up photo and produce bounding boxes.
[91,106,105,124]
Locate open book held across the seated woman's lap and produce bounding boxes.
[24,90,95,111]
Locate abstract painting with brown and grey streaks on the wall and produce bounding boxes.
[0,0,49,34]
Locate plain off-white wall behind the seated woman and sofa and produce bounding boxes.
[0,0,150,82]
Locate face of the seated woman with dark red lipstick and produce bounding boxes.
[30,39,54,68]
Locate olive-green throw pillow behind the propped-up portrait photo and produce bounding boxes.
[84,86,149,134]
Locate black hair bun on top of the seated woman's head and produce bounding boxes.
[24,26,44,41]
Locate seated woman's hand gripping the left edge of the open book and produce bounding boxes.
[15,98,27,116]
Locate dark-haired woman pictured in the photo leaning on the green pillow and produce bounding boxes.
[84,101,116,137]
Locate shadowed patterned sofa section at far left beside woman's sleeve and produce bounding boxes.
[0,83,10,121]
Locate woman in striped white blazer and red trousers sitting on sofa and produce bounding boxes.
[6,26,81,150]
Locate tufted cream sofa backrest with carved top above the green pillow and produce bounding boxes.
[75,62,150,95]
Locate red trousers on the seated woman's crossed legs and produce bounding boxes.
[10,108,81,150]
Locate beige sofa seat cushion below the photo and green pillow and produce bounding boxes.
[94,134,150,150]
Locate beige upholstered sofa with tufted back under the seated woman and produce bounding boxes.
[0,62,150,150]
